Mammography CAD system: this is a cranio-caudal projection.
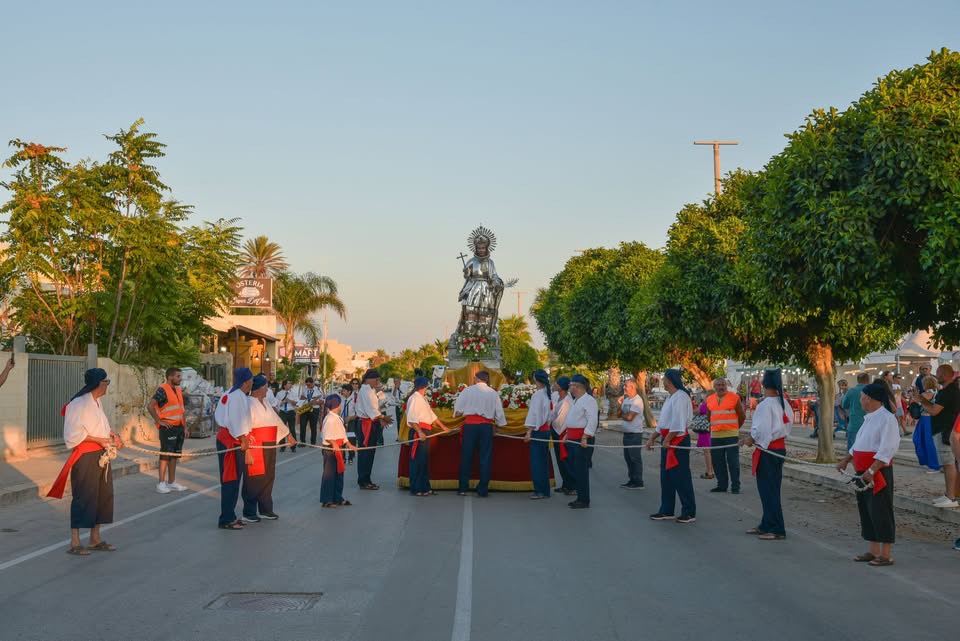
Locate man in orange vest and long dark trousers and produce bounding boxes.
[707,378,747,494]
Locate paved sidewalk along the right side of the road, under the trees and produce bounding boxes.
[600,419,960,525]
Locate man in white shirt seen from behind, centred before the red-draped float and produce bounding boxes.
[453,370,507,497]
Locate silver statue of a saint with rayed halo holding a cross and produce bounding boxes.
[457,225,503,336]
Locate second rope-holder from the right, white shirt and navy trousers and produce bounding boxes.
[744,369,793,541]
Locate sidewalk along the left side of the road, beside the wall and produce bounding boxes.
[0,437,216,506]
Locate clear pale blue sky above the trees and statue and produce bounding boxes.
[0,0,960,351]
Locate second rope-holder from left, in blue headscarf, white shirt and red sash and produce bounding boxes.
[213,367,254,530]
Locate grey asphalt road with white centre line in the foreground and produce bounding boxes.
[0,435,960,641]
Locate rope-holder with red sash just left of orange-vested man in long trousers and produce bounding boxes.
[647,369,697,524]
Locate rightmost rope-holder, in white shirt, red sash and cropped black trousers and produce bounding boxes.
[837,383,900,567]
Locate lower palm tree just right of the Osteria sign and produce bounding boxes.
[273,272,347,360]
